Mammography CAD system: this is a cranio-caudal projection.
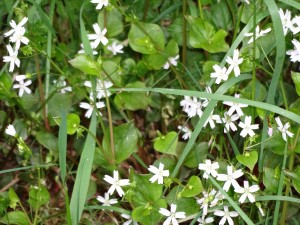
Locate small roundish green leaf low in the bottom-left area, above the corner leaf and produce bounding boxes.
[28,186,50,211]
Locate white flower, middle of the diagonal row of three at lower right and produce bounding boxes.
[217,166,244,191]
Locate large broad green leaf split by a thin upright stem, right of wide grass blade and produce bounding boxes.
[102,122,138,163]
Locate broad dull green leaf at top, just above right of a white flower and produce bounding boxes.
[98,8,124,38]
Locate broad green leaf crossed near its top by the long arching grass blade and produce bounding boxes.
[114,81,150,111]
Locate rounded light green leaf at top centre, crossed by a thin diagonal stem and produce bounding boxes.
[128,22,165,54]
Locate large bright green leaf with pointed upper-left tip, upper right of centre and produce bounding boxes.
[187,16,229,53]
